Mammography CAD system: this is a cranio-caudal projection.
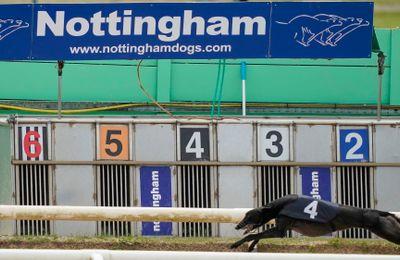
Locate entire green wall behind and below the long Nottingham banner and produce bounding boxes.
[0,30,400,105]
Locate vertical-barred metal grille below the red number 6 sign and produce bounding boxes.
[15,165,52,236]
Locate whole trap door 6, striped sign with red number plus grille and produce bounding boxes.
[14,124,53,236]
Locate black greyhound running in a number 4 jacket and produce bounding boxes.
[231,195,400,252]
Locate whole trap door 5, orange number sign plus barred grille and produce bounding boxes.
[96,124,134,237]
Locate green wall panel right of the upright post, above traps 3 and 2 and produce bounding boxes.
[171,64,390,104]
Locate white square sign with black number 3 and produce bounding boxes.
[258,126,290,161]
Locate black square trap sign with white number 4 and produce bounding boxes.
[179,127,210,161]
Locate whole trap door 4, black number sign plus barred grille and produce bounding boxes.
[176,125,218,237]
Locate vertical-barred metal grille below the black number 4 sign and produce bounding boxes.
[177,165,216,237]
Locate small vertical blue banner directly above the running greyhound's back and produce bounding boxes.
[300,167,332,201]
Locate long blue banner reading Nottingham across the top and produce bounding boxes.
[0,2,373,60]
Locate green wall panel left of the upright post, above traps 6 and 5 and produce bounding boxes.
[0,62,157,102]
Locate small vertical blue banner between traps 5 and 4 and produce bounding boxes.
[140,166,172,236]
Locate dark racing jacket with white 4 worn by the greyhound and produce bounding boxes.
[278,196,339,224]
